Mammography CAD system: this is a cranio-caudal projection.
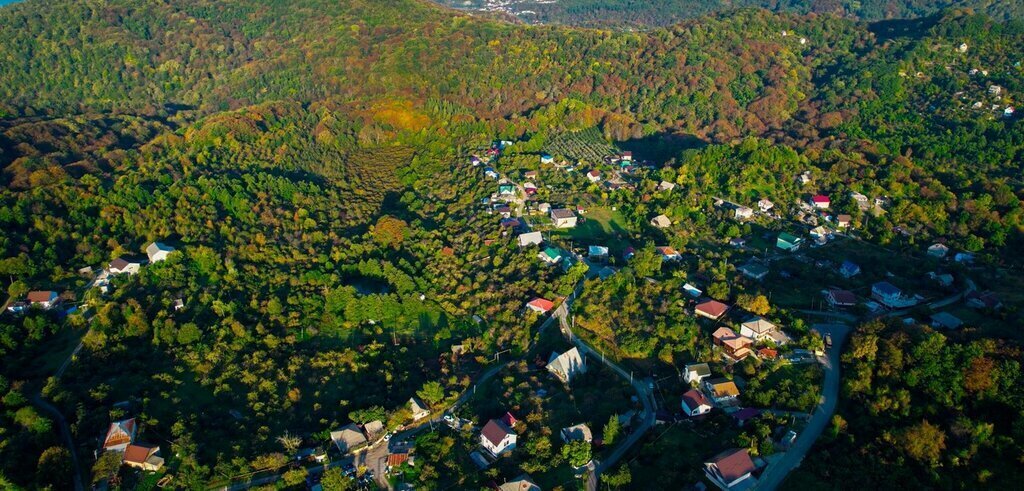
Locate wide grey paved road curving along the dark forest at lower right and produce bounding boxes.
[757,324,850,491]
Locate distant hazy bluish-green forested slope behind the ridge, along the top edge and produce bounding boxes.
[436,0,1024,28]
